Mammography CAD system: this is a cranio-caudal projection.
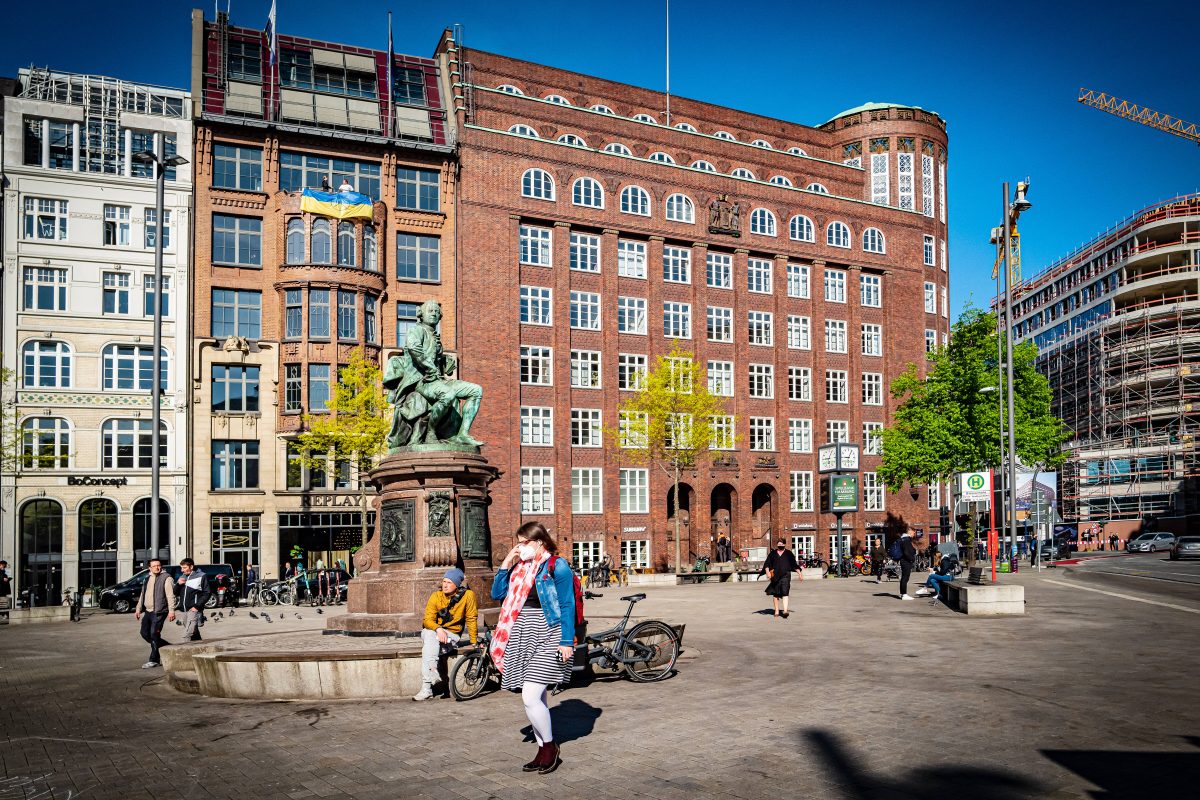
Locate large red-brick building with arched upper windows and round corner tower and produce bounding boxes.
[439,35,948,569]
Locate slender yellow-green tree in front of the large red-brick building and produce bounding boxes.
[608,345,734,575]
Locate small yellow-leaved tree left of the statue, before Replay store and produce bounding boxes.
[295,348,391,563]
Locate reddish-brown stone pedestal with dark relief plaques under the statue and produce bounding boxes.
[325,445,499,634]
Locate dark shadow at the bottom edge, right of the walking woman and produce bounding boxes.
[802,728,1042,800]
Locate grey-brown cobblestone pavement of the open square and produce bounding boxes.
[0,570,1200,800]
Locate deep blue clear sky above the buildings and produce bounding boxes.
[0,0,1200,311]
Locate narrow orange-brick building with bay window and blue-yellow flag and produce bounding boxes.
[191,11,455,577]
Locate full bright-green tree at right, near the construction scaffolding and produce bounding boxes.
[877,308,1072,554]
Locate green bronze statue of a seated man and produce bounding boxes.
[383,300,484,449]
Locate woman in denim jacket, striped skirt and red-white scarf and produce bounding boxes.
[491,522,575,775]
